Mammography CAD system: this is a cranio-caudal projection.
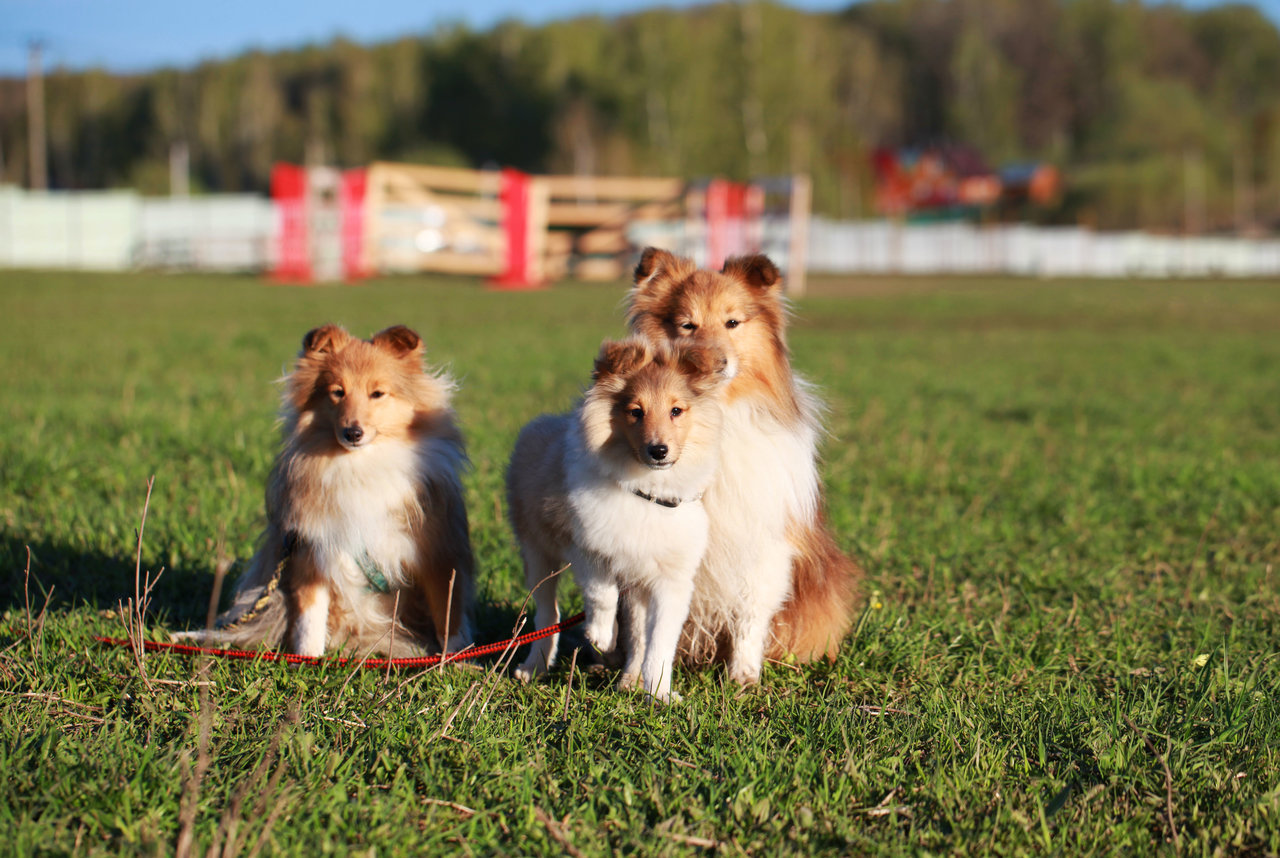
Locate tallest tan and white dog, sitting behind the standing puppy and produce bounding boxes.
[627,247,863,684]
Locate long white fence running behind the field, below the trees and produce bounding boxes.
[0,187,1280,278]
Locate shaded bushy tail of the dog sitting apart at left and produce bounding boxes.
[170,535,287,647]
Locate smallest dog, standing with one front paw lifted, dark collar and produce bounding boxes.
[507,338,726,702]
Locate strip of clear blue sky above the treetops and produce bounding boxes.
[0,0,1280,76]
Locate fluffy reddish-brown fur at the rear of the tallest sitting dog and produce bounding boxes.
[765,519,863,662]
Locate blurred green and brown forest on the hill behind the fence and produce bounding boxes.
[0,0,1280,232]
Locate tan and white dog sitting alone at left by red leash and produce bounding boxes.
[180,325,475,656]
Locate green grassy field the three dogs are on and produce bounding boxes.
[0,271,1280,855]
